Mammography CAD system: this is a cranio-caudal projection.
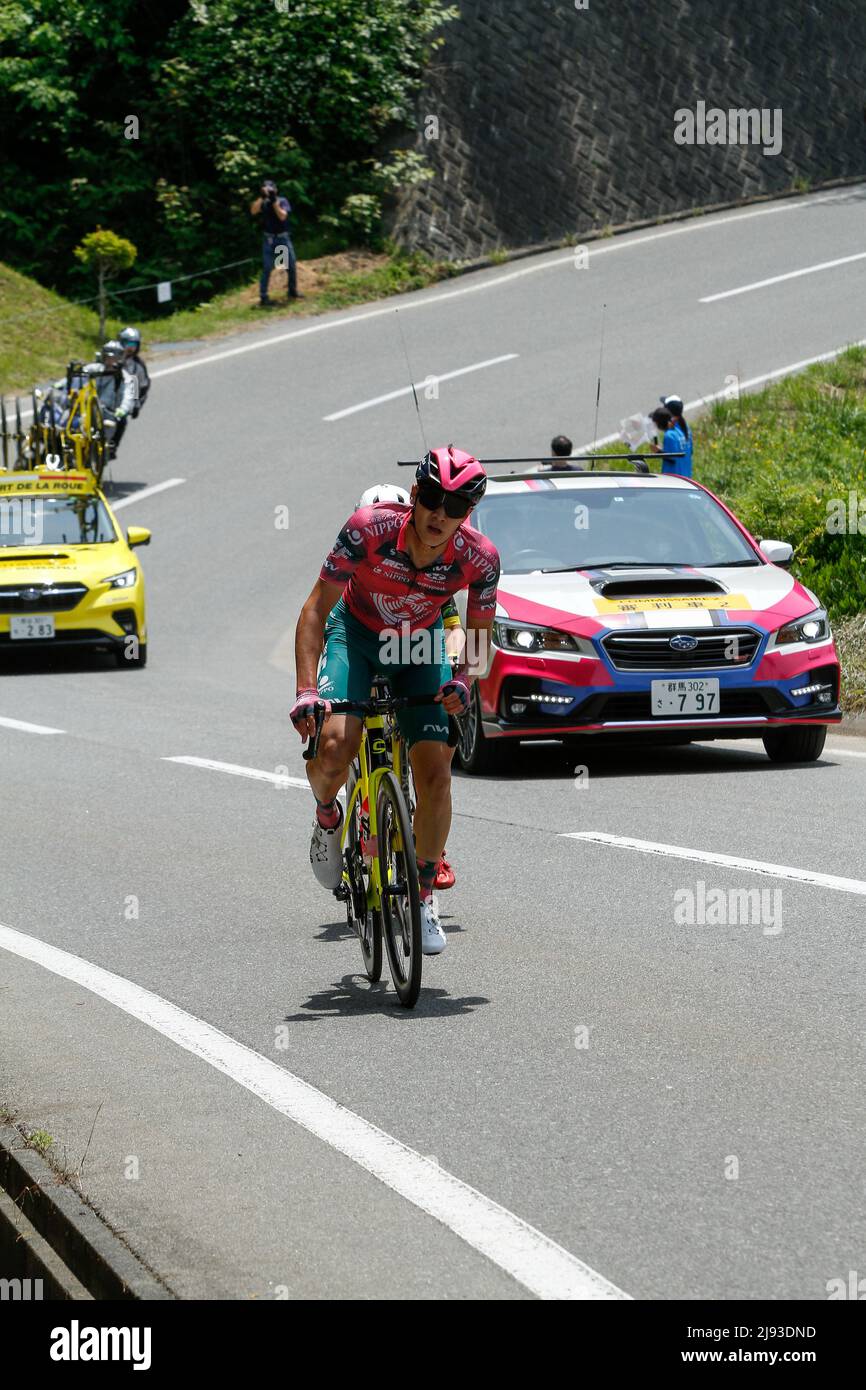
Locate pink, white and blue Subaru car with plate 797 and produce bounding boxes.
[457,460,842,771]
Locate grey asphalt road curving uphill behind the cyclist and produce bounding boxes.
[0,186,866,1300]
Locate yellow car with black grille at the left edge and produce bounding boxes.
[0,468,150,666]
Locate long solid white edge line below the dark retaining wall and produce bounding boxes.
[140,185,858,378]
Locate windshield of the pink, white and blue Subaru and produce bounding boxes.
[471,485,760,574]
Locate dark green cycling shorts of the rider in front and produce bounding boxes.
[318,598,452,748]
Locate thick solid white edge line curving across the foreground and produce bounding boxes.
[0,926,628,1300]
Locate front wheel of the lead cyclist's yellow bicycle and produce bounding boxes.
[375,771,421,1009]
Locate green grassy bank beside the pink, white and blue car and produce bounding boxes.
[601,348,866,710]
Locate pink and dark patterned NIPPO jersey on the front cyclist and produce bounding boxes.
[321,502,499,632]
